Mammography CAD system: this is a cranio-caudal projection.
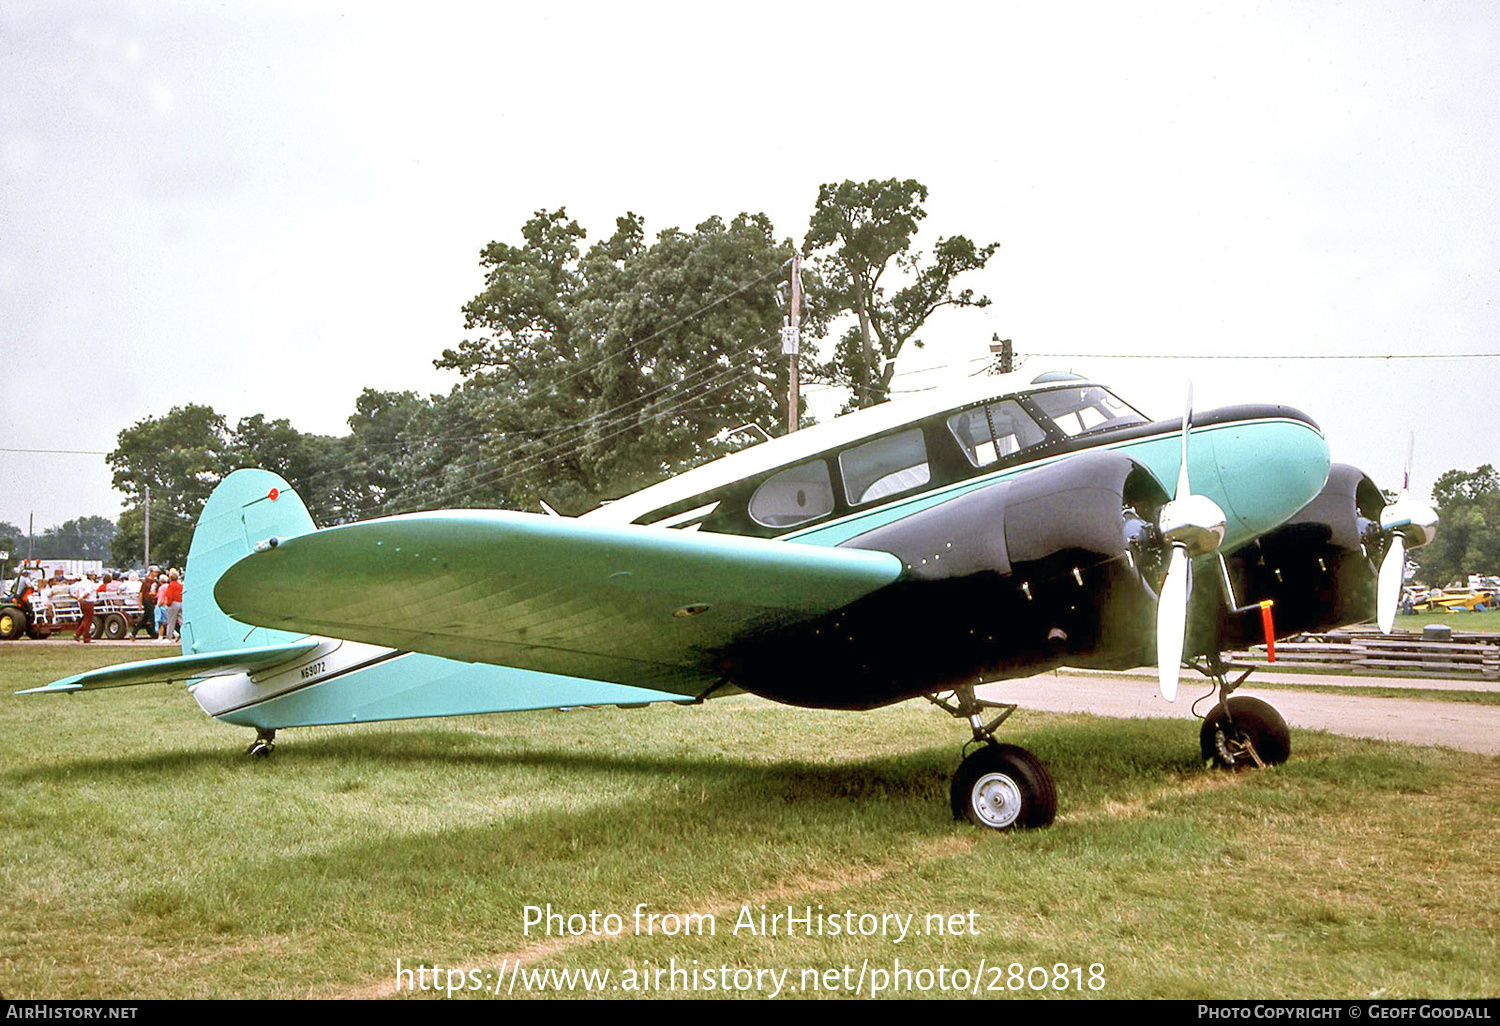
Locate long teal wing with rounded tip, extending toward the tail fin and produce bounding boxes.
[214,510,902,695]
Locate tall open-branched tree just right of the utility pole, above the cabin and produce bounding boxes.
[803,179,999,407]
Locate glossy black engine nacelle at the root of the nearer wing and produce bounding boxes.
[726,452,1167,708]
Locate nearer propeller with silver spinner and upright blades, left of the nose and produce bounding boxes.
[1157,384,1226,702]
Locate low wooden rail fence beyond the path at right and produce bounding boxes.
[1232,629,1500,681]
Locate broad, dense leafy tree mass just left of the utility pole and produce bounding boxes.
[432,210,822,512]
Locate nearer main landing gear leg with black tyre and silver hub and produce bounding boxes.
[927,684,1058,830]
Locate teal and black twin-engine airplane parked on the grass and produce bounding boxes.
[17,375,1437,830]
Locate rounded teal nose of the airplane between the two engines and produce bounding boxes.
[1211,416,1332,536]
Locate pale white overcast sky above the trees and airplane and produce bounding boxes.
[0,0,1500,531]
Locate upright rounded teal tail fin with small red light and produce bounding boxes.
[183,470,317,656]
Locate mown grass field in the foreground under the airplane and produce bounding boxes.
[0,642,1500,999]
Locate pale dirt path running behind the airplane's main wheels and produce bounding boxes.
[980,671,1500,755]
